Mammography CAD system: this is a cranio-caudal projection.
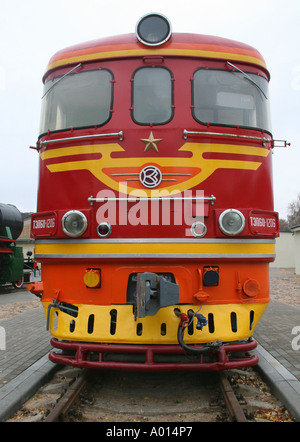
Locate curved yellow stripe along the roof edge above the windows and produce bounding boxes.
[47,48,266,70]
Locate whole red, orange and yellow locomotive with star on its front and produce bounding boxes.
[31,14,278,370]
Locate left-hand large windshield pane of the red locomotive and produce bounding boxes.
[40,69,113,134]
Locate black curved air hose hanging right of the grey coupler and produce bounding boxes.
[175,307,223,354]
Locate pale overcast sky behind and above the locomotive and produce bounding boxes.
[0,0,300,218]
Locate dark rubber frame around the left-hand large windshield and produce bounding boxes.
[39,67,115,138]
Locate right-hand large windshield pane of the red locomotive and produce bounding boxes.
[193,69,271,131]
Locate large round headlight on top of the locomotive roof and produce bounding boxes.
[136,13,172,46]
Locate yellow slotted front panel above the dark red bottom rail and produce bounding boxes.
[43,303,268,344]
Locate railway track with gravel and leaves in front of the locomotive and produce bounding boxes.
[11,368,292,425]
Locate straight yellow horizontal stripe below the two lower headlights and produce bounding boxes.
[35,242,275,258]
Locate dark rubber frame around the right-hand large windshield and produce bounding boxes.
[191,67,271,134]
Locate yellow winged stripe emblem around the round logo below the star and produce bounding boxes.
[41,143,270,196]
